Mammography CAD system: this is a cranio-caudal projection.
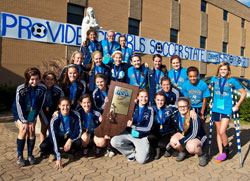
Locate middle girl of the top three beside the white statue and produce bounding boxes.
[101,30,120,64]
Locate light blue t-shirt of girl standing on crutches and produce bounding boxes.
[209,77,242,115]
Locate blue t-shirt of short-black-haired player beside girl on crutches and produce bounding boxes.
[181,80,210,107]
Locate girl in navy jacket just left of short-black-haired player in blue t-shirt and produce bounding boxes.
[160,77,182,106]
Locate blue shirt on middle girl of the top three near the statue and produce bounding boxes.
[101,40,120,64]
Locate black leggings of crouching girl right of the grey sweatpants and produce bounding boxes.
[148,133,173,149]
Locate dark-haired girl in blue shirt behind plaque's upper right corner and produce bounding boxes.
[126,54,148,89]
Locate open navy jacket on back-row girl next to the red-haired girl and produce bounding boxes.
[147,68,168,105]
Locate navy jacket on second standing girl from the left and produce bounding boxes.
[39,85,64,126]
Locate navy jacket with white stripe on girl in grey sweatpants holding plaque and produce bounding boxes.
[127,105,154,138]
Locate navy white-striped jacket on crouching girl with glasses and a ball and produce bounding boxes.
[171,111,207,145]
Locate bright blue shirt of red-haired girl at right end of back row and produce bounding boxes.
[168,67,188,90]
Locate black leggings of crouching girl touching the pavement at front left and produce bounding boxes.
[40,136,82,154]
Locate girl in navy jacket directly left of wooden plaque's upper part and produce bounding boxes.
[93,74,108,113]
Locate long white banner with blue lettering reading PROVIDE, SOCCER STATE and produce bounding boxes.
[0,12,249,67]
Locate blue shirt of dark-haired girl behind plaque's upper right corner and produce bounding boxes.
[126,66,148,89]
